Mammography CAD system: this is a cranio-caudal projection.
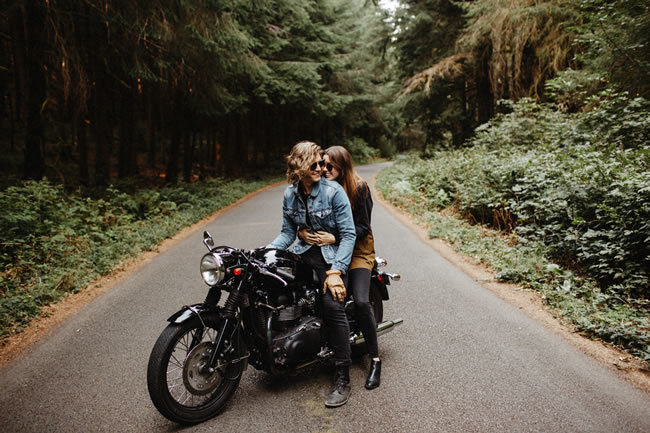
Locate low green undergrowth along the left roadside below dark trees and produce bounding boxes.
[0,178,274,339]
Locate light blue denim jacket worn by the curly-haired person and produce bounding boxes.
[271,179,356,272]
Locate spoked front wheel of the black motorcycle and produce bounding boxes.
[147,317,246,424]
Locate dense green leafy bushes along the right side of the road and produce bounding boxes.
[378,93,650,359]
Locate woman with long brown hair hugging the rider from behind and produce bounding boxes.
[299,146,381,389]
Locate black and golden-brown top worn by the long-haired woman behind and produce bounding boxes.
[350,182,375,270]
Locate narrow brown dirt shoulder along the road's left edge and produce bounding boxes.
[0,181,284,368]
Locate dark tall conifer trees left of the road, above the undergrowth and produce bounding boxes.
[0,0,390,186]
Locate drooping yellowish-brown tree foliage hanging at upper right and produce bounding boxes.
[458,0,580,99]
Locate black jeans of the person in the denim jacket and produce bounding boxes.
[301,246,352,367]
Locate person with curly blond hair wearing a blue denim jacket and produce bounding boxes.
[270,141,356,407]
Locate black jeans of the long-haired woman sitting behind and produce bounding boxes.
[348,268,379,358]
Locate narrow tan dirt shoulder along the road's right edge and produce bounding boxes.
[371,181,650,394]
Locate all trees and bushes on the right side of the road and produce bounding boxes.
[370,0,650,368]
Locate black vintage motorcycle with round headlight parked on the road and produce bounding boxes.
[147,231,403,424]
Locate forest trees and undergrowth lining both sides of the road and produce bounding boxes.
[0,0,650,361]
